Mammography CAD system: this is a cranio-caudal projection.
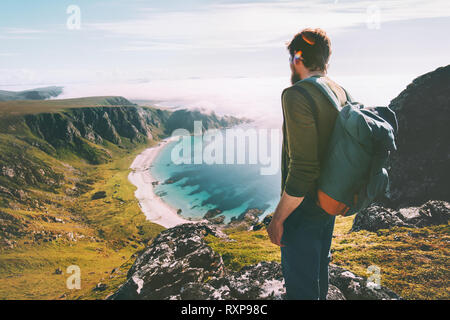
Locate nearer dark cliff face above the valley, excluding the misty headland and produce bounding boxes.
[25,106,169,164]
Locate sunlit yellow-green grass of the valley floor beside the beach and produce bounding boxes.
[0,137,164,299]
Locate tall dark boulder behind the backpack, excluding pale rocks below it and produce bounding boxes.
[385,65,450,208]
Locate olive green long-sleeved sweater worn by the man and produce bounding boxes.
[281,77,346,197]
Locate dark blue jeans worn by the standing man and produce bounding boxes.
[281,196,335,300]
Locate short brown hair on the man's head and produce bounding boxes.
[287,28,331,71]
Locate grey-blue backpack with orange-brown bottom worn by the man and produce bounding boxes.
[293,77,398,216]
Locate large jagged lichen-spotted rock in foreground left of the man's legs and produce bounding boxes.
[111,223,226,299]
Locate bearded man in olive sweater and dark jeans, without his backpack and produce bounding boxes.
[267,29,346,299]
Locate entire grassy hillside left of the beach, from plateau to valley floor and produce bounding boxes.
[0,97,167,299]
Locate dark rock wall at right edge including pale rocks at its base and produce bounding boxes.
[352,65,450,231]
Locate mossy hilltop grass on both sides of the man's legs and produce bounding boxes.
[207,217,450,300]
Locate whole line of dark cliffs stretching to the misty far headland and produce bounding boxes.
[25,106,243,155]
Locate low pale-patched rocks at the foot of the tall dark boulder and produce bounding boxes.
[351,200,450,232]
